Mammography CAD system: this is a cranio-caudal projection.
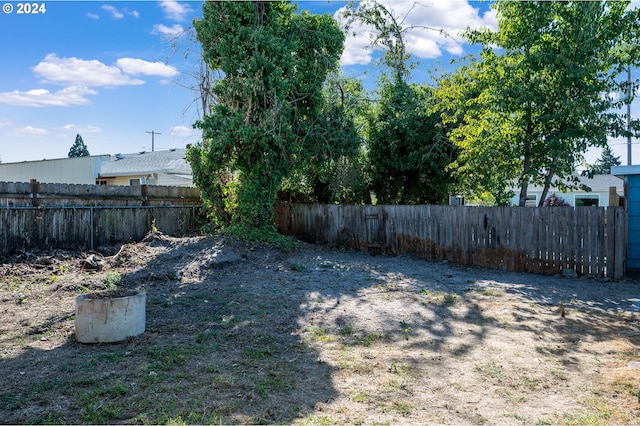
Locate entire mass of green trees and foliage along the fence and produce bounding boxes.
[188,0,640,216]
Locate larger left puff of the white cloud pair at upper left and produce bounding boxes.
[33,53,144,87]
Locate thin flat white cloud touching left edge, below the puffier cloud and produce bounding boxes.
[0,86,97,107]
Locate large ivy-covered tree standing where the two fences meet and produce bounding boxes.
[188,1,344,228]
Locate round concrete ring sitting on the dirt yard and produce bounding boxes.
[75,290,146,343]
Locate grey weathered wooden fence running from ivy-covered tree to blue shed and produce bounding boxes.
[276,203,625,279]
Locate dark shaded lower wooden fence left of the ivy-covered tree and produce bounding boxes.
[0,205,204,256]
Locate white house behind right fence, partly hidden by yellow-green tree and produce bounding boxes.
[511,175,624,206]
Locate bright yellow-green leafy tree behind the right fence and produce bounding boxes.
[438,0,639,206]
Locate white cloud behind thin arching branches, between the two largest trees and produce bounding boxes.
[334,0,497,65]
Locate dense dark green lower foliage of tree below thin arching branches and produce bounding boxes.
[369,81,455,204]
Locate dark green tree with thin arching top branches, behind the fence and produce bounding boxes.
[345,1,456,204]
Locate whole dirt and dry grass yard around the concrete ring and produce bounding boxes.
[0,235,640,424]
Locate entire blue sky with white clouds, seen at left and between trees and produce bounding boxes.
[0,0,640,163]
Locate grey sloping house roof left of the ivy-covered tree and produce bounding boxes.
[100,149,191,177]
